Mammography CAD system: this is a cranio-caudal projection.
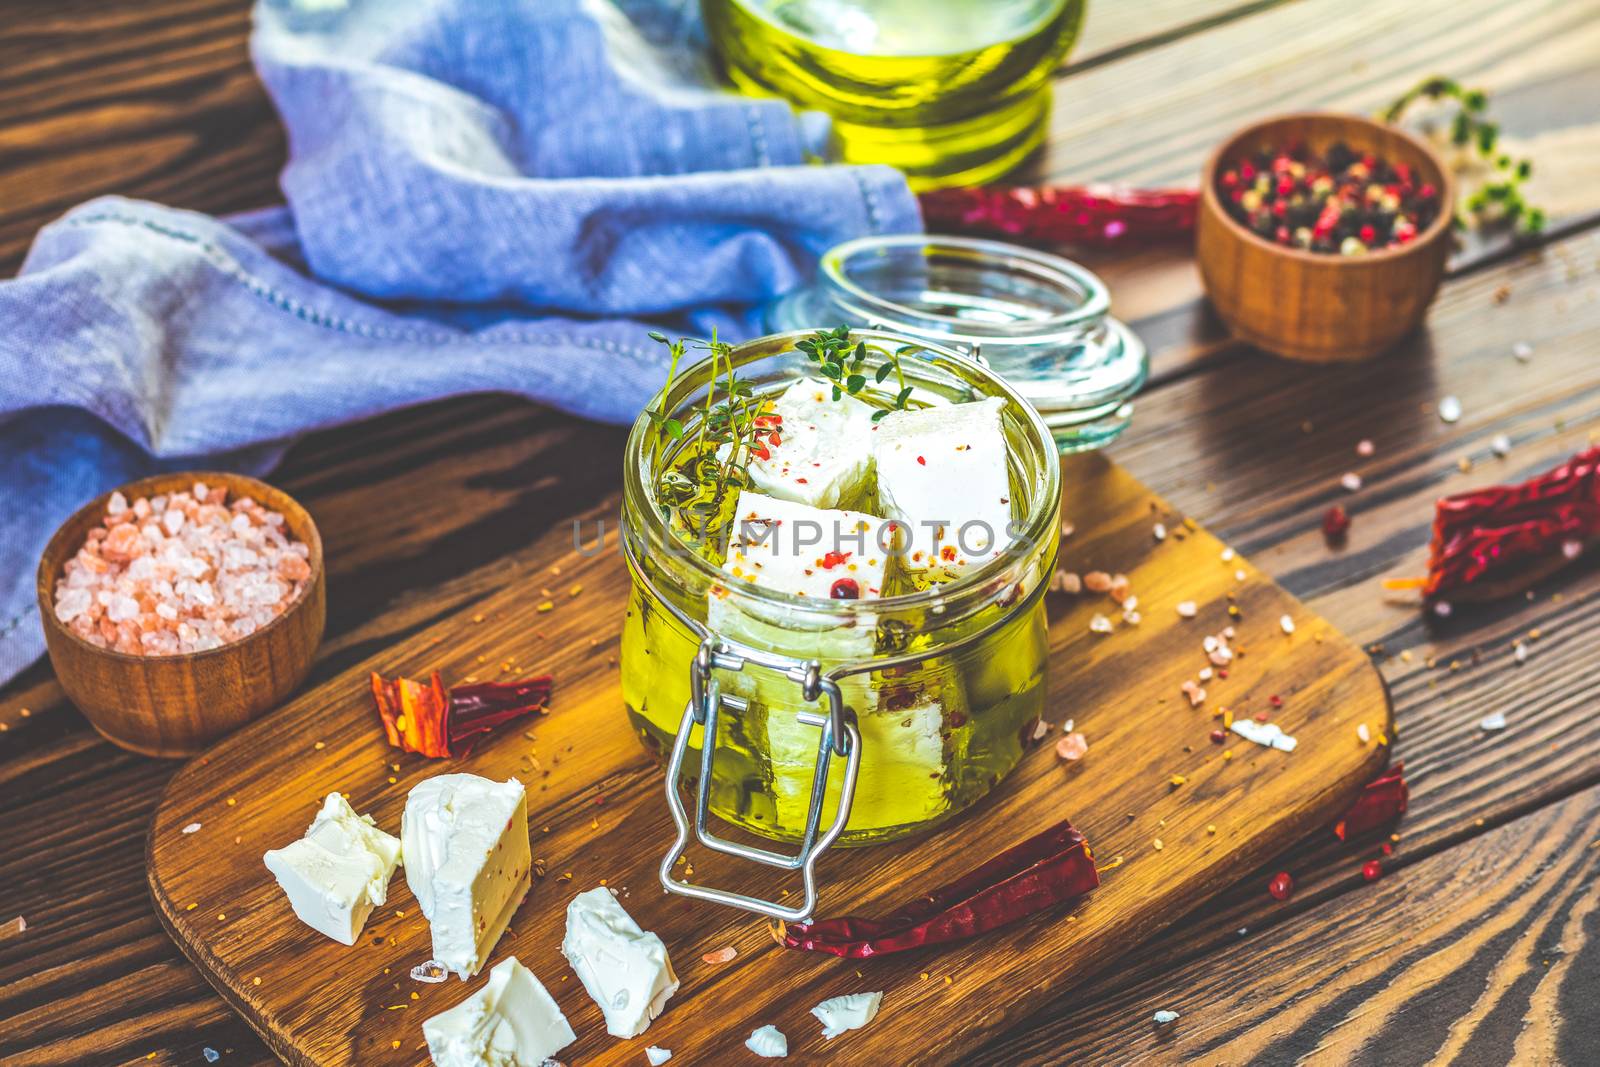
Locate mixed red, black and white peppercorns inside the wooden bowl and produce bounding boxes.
[1218,141,1440,256]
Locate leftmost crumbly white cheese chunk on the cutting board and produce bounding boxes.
[262,793,400,945]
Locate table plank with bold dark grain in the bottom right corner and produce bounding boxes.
[966,789,1600,1065]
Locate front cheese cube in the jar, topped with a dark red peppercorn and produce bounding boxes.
[722,490,888,600]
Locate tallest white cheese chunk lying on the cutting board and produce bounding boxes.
[400,774,533,979]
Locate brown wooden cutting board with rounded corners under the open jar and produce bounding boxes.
[149,456,1392,1065]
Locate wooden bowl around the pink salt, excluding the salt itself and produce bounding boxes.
[38,470,326,757]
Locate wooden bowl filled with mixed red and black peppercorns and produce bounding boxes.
[1195,112,1456,363]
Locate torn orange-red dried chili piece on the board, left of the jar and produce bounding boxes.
[373,670,555,760]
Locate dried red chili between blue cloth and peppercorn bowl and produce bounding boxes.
[920,186,1198,245]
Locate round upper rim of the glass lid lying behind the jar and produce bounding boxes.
[818,234,1110,346]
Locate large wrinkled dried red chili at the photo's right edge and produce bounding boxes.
[1384,448,1600,601]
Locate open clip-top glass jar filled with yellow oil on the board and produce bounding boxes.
[621,331,1061,920]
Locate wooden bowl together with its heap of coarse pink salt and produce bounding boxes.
[38,472,325,757]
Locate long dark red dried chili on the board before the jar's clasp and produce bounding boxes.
[782,822,1099,960]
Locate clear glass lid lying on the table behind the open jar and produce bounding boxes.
[763,234,1149,453]
